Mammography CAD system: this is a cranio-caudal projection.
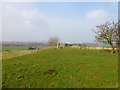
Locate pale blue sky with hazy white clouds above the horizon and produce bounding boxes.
[2,2,118,43]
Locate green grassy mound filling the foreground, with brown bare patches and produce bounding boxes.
[2,48,118,88]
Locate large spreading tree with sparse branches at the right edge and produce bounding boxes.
[93,22,119,53]
